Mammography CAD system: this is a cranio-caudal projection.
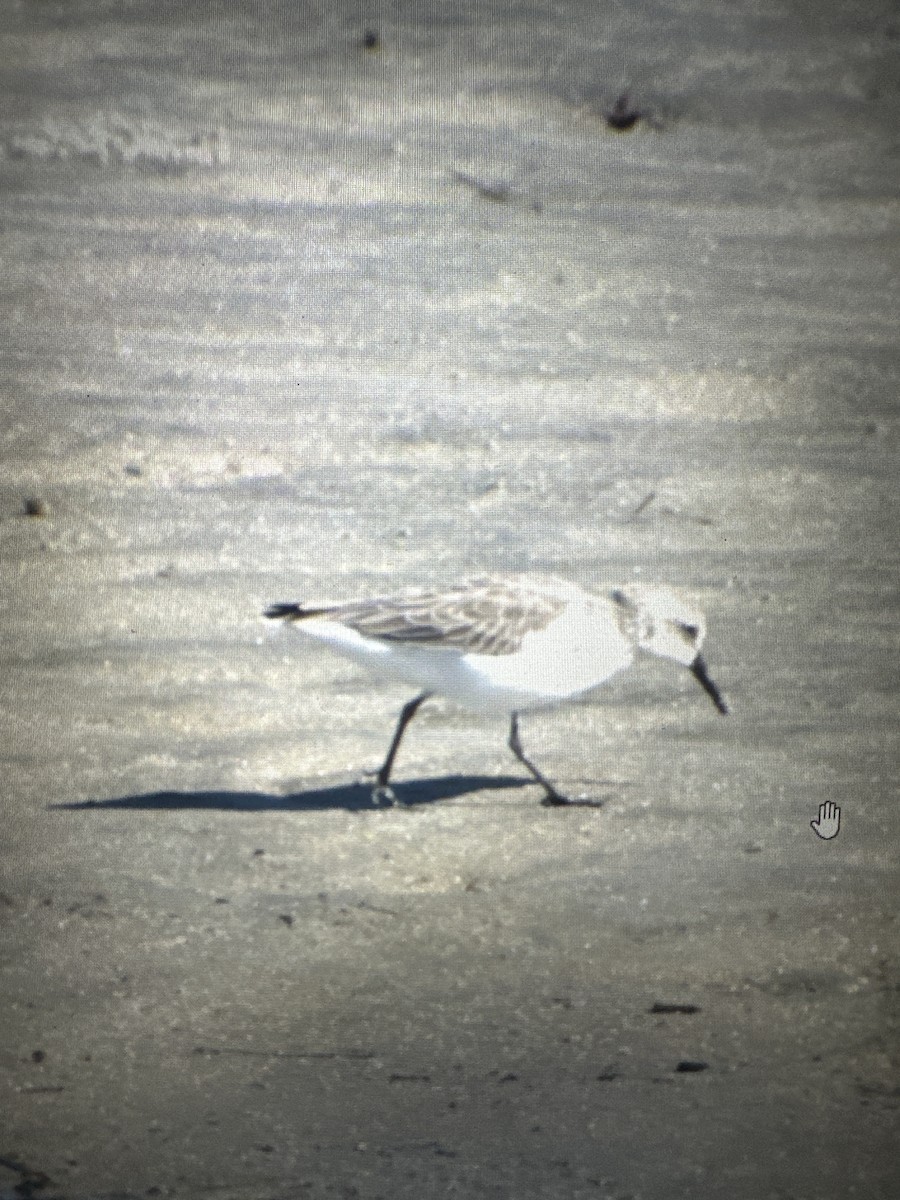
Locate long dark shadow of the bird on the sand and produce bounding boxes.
[48,775,534,812]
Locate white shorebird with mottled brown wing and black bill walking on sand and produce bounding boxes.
[265,578,728,804]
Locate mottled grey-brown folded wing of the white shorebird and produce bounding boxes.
[334,581,565,655]
